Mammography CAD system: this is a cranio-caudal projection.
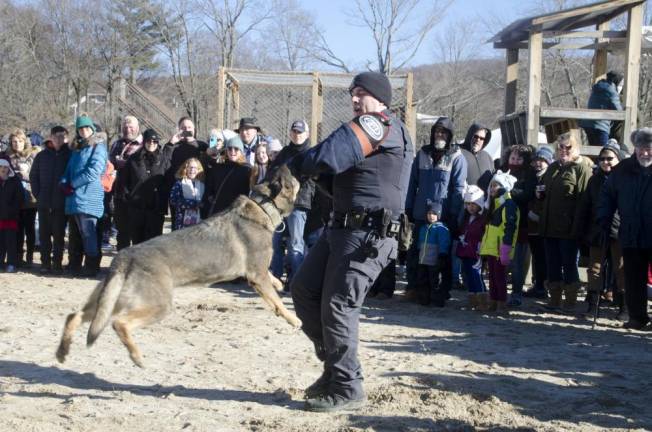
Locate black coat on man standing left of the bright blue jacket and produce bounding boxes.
[29,143,71,209]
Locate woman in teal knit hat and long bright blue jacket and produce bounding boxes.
[60,115,108,276]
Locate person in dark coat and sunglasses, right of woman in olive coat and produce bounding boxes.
[576,139,627,320]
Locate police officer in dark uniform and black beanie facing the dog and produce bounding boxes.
[289,72,414,412]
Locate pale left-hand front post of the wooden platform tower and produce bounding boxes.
[526,30,543,146]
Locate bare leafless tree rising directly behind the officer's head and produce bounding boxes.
[354,0,453,75]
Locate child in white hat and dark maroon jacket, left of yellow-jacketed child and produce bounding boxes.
[457,185,487,310]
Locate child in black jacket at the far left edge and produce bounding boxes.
[0,158,25,273]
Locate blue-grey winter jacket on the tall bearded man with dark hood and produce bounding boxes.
[405,145,467,227]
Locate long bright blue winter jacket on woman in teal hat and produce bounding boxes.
[61,133,108,218]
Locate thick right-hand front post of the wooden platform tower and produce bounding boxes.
[623,3,645,142]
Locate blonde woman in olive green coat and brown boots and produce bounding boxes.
[536,132,591,313]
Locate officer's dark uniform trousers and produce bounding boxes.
[291,229,397,399]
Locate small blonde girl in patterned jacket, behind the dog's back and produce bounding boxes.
[170,158,204,231]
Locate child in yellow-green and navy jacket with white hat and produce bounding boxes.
[480,170,519,311]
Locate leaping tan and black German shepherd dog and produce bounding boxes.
[56,167,301,367]
